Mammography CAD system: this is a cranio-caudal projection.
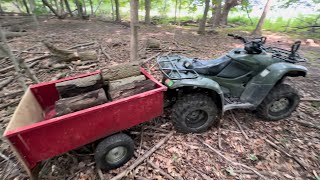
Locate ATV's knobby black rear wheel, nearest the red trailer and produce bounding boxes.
[172,94,218,133]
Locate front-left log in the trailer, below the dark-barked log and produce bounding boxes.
[55,89,108,116]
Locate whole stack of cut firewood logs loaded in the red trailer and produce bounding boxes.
[55,63,155,116]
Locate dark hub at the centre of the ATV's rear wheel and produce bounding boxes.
[186,110,208,128]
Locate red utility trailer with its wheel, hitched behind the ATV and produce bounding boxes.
[4,68,167,177]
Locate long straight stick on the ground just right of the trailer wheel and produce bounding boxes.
[111,131,174,180]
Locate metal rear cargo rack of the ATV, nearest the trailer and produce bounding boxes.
[157,55,199,80]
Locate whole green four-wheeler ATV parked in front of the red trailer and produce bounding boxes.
[157,34,307,133]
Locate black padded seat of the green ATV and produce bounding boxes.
[184,56,231,76]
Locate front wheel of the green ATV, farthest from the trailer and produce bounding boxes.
[257,84,300,121]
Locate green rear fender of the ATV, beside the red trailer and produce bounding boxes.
[169,77,224,109]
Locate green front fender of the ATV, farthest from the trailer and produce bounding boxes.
[240,62,308,106]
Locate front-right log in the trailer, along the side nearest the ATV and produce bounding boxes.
[109,79,155,100]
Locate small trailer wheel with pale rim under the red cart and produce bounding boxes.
[94,133,134,170]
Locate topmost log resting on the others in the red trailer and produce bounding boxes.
[102,62,141,81]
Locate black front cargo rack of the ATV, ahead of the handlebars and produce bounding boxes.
[266,47,306,63]
